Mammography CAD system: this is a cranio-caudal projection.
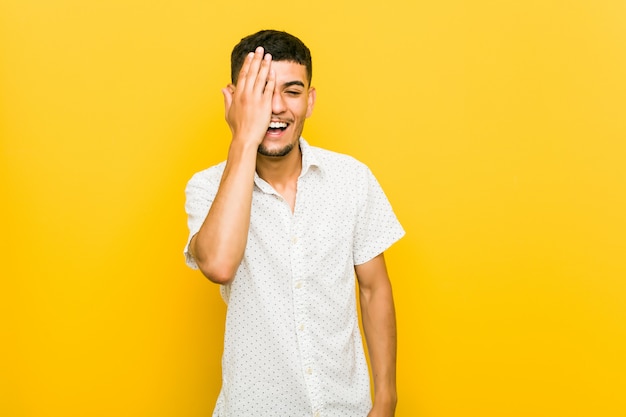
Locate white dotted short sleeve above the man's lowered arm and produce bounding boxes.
[353,168,404,265]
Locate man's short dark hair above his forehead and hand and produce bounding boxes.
[230,30,313,85]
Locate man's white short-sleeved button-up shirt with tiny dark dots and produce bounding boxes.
[185,139,404,417]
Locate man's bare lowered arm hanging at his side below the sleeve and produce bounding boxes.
[355,253,397,417]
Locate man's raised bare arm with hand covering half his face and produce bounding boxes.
[189,47,276,284]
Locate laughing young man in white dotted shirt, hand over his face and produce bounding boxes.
[185,31,404,417]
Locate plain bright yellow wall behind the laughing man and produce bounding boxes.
[0,0,626,417]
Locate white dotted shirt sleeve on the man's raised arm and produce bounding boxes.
[183,166,221,269]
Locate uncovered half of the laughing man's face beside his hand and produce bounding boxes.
[258,61,315,157]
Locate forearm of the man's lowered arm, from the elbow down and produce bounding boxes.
[360,280,397,415]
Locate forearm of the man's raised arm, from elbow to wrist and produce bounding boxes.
[190,139,257,284]
